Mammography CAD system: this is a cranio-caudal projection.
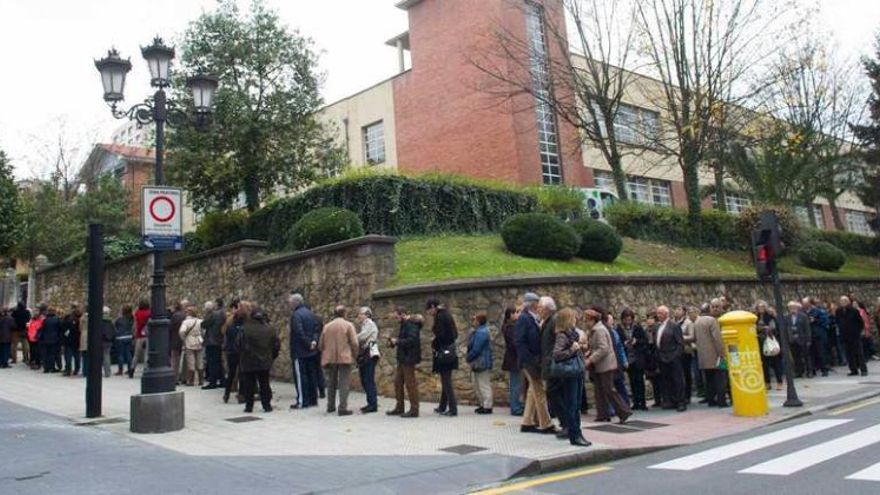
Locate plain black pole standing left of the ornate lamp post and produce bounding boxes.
[86,223,104,418]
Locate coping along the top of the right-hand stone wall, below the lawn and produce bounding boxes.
[373,275,880,300]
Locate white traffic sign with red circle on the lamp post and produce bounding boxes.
[141,186,183,251]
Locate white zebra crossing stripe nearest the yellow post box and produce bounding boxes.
[648,419,852,471]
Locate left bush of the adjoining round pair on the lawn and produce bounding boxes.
[501,213,581,260]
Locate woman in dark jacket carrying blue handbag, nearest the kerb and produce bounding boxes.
[548,308,592,447]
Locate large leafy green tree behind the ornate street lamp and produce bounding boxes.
[168,0,338,211]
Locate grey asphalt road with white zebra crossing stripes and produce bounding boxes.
[478,399,880,495]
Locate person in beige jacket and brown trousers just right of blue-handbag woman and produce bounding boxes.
[584,309,632,424]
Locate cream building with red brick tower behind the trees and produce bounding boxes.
[320,0,872,234]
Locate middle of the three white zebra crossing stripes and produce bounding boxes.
[740,425,880,476]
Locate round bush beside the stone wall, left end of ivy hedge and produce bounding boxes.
[287,208,364,250]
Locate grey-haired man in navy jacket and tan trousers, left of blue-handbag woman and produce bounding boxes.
[513,292,558,435]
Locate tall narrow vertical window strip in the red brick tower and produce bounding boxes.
[526,2,562,185]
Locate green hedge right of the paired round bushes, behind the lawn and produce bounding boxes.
[605,201,748,250]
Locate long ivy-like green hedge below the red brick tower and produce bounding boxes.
[247,174,536,250]
